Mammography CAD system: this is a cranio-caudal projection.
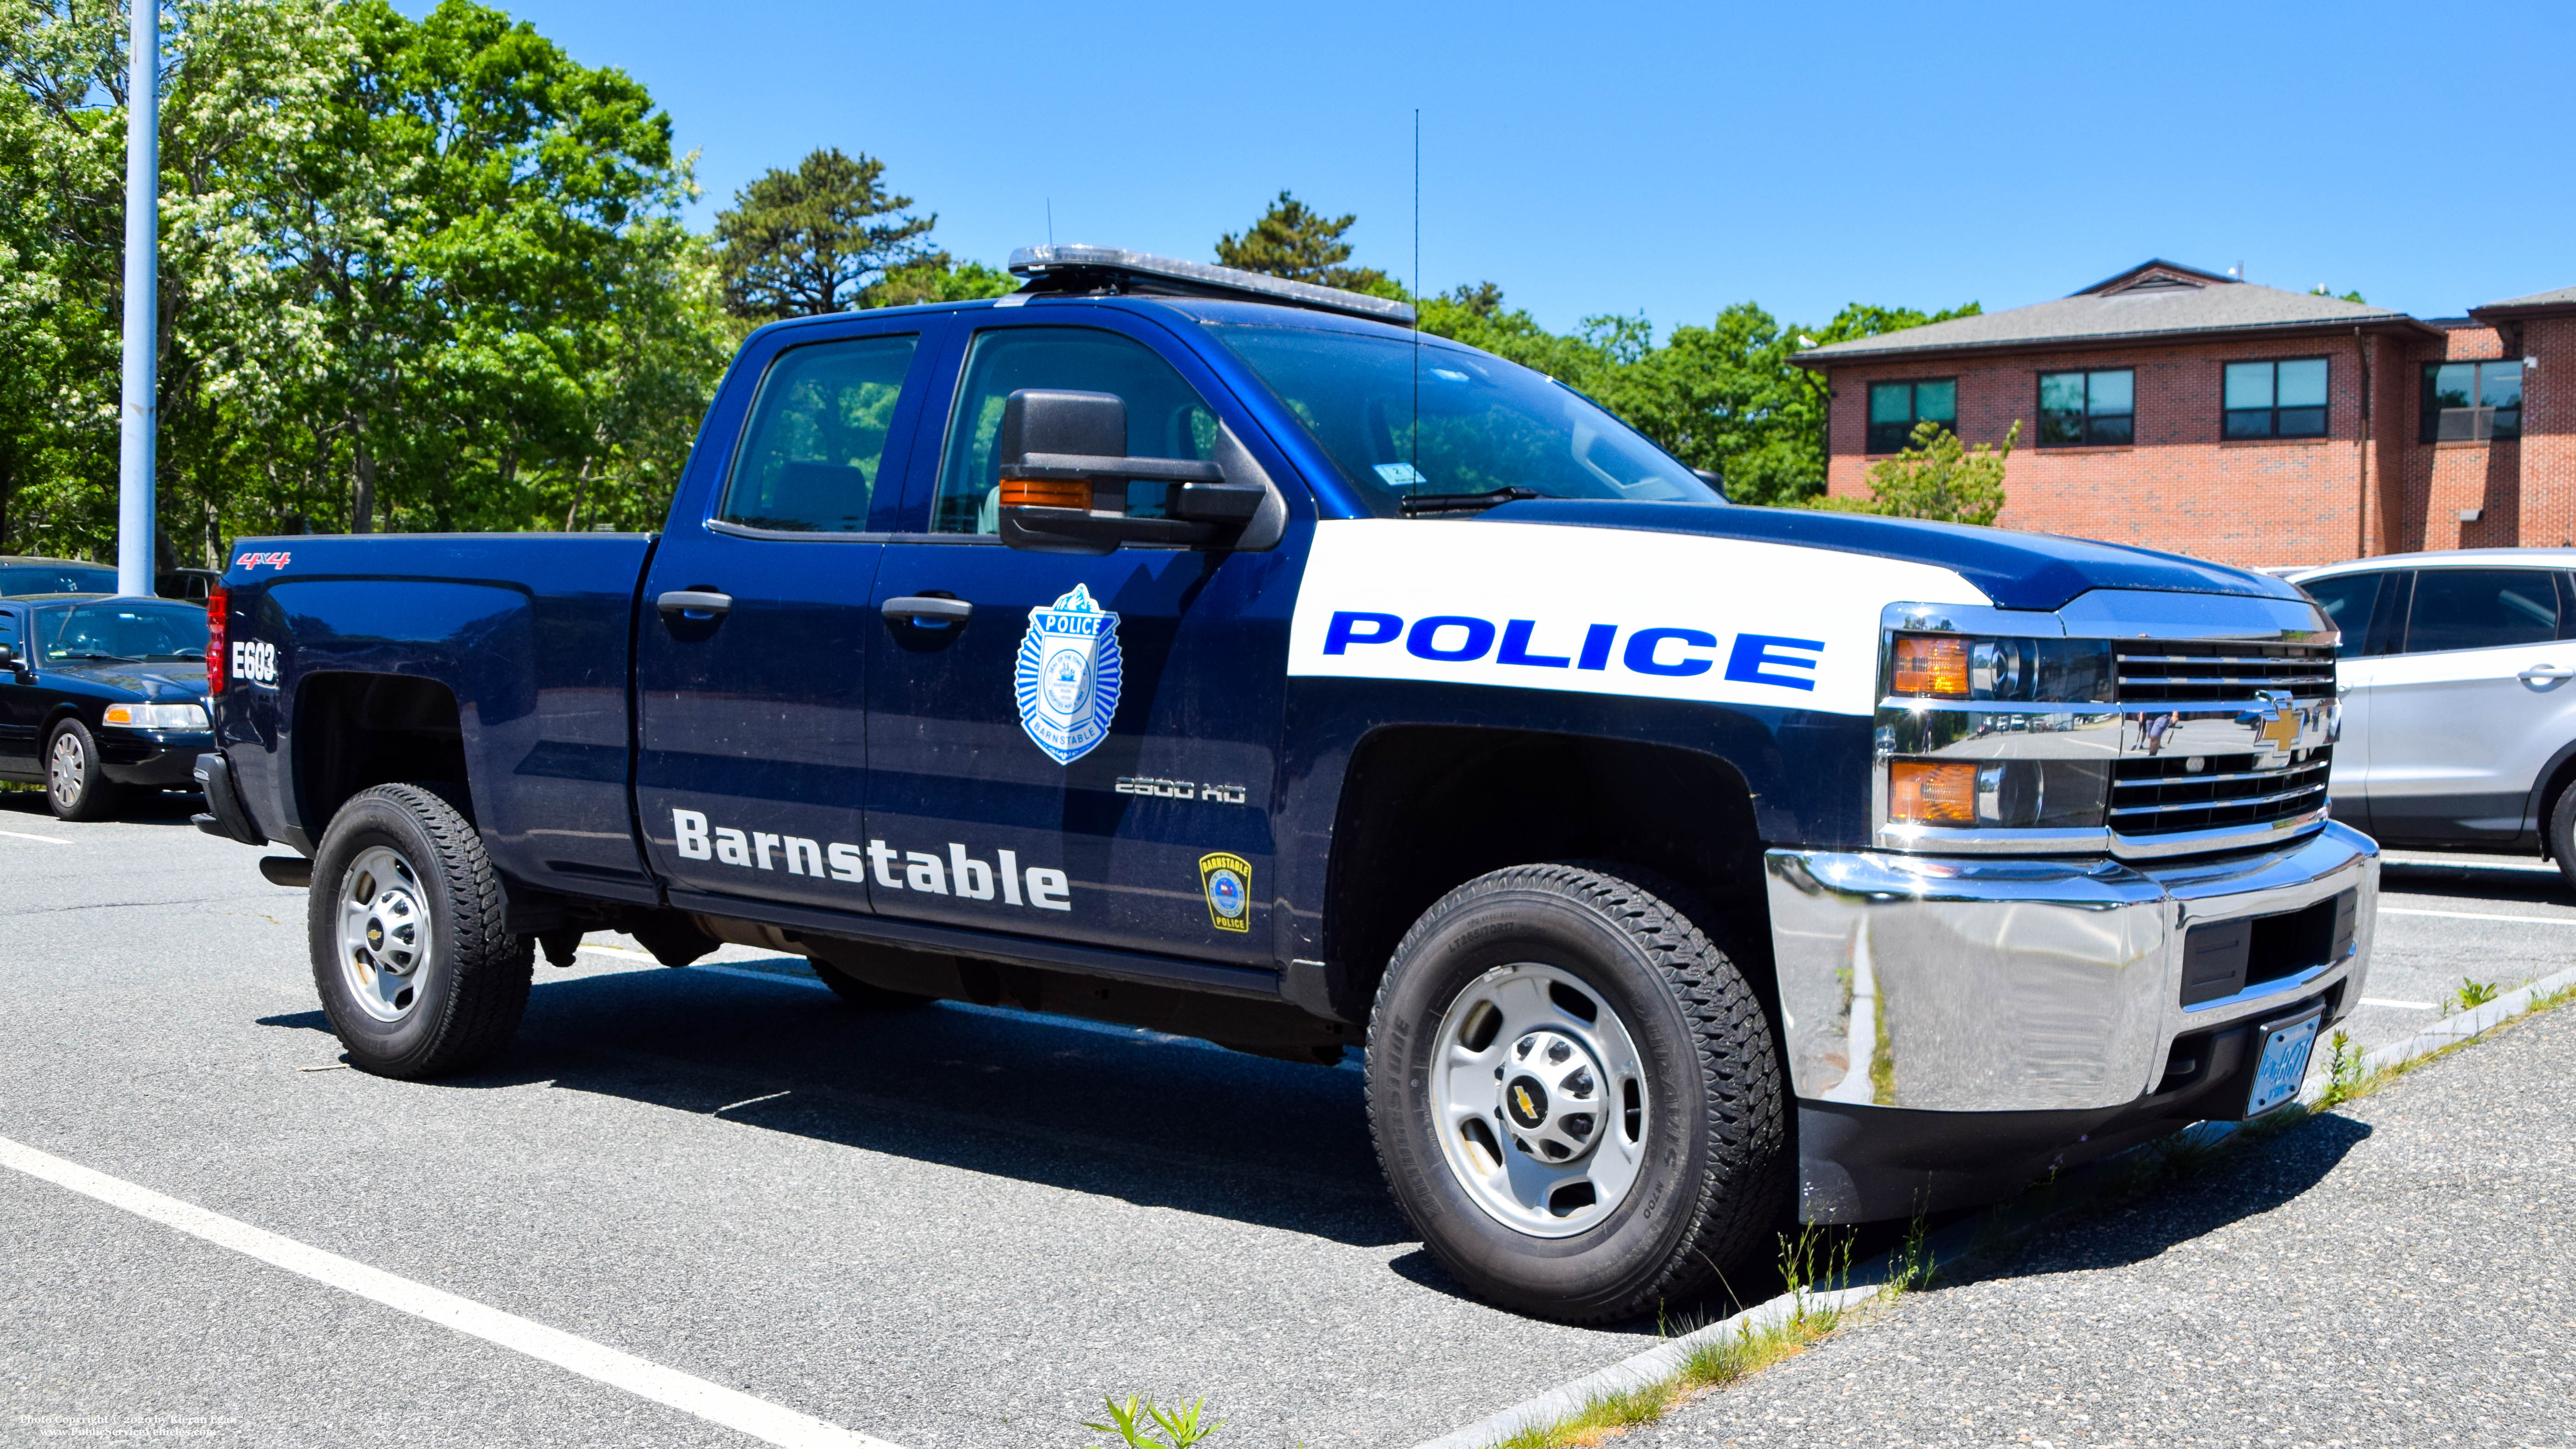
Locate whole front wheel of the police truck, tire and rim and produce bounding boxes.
[1368,865,1790,1323]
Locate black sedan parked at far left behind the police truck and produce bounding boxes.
[0,595,214,821]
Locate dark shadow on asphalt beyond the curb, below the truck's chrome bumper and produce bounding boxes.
[1937,1112,2370,1287]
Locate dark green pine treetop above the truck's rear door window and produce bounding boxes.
[716,147,938,319]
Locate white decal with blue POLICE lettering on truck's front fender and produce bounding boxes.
[1288,517,1989,715]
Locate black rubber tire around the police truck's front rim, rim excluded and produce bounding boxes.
[1368,865,1795,1323]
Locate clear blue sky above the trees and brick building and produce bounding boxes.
[427,0,2576,329]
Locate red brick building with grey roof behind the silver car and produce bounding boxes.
[1795,260,2576,566]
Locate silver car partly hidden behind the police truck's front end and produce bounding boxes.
[2290,548,2576,883]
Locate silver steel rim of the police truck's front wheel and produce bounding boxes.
[1432,962,1654,1238]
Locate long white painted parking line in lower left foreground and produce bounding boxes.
[0,1138,897,1449]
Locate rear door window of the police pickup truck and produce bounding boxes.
[719,337,920,533]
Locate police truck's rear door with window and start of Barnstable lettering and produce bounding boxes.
[636,314,945,911]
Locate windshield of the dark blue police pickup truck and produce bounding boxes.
[1211,324,1721,515]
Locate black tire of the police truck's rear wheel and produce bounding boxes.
[306,785,536,1078]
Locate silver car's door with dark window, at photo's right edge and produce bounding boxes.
[2367,566,2576,847]
